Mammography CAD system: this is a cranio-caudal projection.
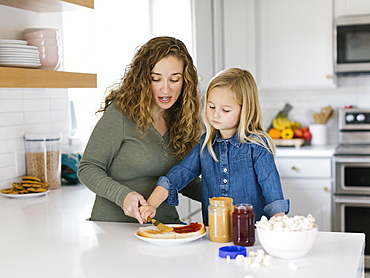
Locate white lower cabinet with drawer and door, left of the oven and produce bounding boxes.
[276,157,332,231]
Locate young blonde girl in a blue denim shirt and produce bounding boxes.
[140,68,289,225]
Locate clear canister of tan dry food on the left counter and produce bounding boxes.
[24,133,62,188]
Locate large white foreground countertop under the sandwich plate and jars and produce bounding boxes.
[0,185,365,278]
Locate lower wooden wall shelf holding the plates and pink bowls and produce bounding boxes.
[0,67,97,88]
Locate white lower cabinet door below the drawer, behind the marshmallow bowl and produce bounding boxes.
[281,179,331,231]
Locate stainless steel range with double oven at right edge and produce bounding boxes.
[332,109,370,268]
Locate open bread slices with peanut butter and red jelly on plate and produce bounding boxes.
[137,222,206,239]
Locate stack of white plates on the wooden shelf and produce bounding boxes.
[0,39,41,68]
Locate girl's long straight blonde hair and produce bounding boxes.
[202,68,276,161]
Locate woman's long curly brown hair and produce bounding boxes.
[98,37,201,159]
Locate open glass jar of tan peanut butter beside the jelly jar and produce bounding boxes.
[208,197,233,242]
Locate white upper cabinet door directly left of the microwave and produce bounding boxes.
[257,0,334,89]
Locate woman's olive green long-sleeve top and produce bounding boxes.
[78,103,201,223]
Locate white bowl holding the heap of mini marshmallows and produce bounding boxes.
[257,226,317,259]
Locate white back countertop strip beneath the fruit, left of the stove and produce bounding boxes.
[276,145,336,157]
